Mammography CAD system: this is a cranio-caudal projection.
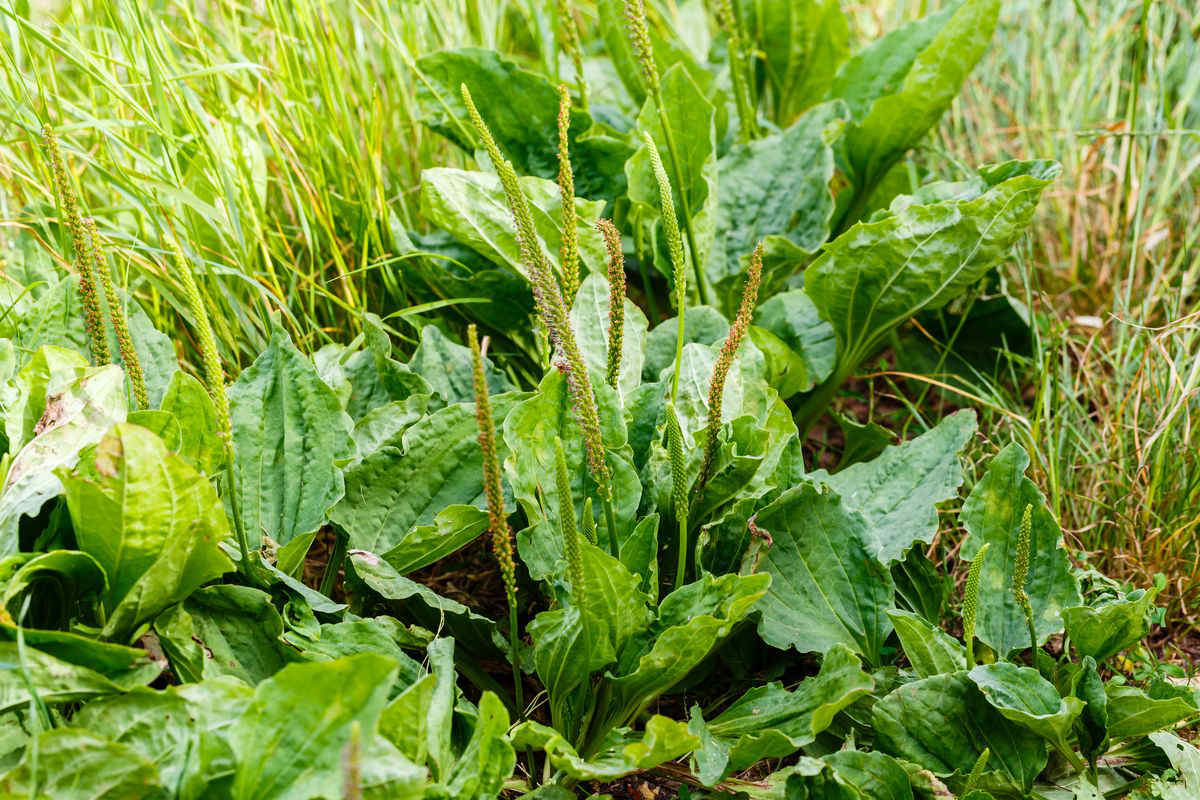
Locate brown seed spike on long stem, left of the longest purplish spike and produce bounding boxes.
[467,325,524,720]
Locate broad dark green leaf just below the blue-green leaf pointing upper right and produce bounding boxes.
[756,481,894,664]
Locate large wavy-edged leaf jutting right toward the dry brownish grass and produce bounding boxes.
[804,162,1058,371]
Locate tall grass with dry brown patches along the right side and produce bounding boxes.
[873,0,1200,626]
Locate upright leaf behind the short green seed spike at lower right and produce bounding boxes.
[961,444,1080,655]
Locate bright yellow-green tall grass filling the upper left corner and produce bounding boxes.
[0,0,530,365]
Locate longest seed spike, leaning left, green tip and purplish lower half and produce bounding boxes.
[460,84,619,557]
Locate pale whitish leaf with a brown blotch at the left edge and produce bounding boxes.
[0,365,126,555]
